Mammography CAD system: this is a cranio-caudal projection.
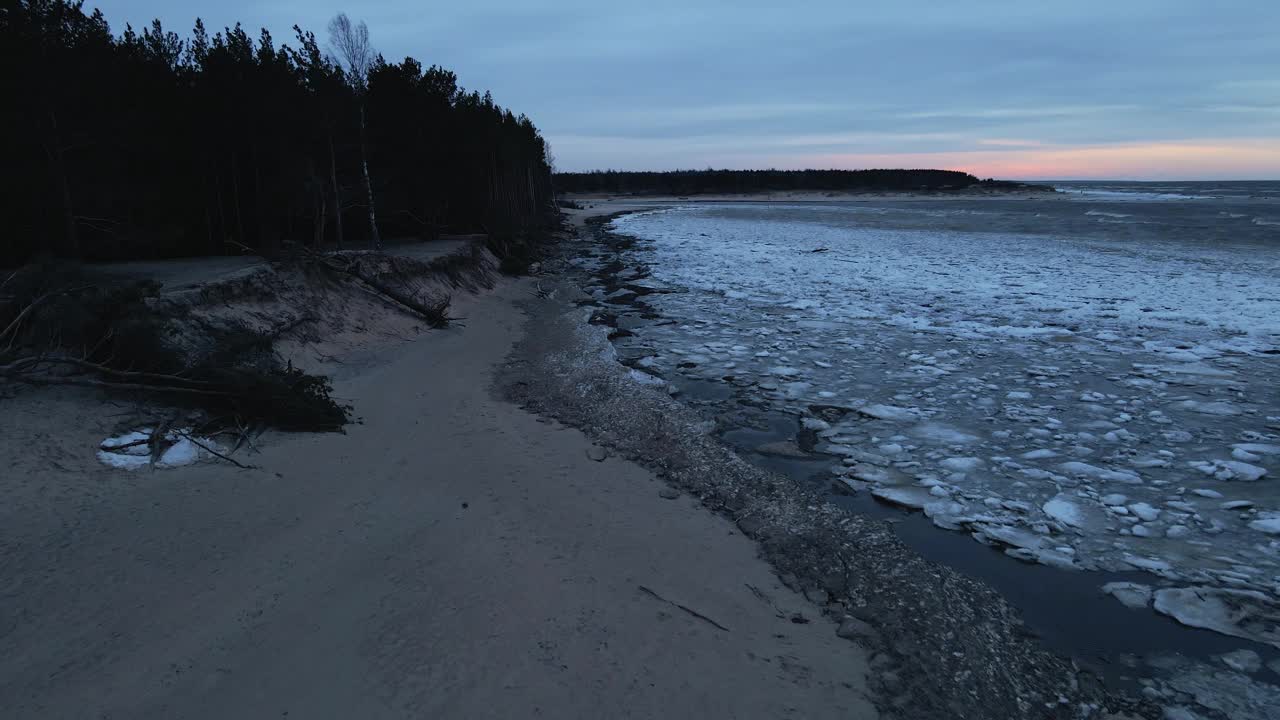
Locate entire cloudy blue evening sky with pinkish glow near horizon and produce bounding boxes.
[87,0,1280,179]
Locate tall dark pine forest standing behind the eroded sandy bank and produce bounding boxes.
[0,0,552,266]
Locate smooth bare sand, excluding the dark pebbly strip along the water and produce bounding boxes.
[0,284,874,719]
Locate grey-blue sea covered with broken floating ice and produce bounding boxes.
[599,189,1280,647]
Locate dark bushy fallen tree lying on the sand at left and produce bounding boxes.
[0,268,348,430]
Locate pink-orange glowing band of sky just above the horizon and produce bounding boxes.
[778,140,1280,179]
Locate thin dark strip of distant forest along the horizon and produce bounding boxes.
[554,170,1030,195]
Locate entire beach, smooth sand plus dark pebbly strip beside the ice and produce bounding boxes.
[0,199,1192,719]
